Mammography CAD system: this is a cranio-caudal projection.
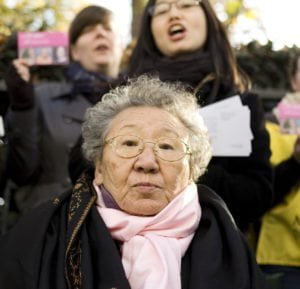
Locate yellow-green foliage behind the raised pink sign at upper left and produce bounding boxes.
[0,0,72,80]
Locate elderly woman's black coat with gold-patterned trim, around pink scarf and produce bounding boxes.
[0,172,267,289]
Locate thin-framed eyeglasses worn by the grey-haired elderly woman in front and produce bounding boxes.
[105,135,191,162]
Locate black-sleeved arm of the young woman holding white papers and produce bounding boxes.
[200,95,273,224]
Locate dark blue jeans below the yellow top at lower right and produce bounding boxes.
[260,265,300,289]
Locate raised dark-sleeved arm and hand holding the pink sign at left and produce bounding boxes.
[5,59,40,185]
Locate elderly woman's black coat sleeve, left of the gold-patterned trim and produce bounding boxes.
[0,191,70,289]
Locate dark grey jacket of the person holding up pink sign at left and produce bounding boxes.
[6,82,91,210]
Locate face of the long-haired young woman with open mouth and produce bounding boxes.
[151,0,207,58]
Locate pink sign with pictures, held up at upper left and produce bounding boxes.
[18,32,69,65]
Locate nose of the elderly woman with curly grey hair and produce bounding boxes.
[134,144,159,174]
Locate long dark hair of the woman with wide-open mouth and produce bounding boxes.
[128,0,250,97]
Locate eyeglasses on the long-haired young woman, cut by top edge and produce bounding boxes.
[148,0,202,16]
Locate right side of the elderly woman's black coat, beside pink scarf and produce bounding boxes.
[182,186,269,289]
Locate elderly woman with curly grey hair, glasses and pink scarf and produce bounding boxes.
[0,76,266,289]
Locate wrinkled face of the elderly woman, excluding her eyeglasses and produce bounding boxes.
[95,107,191,216]
